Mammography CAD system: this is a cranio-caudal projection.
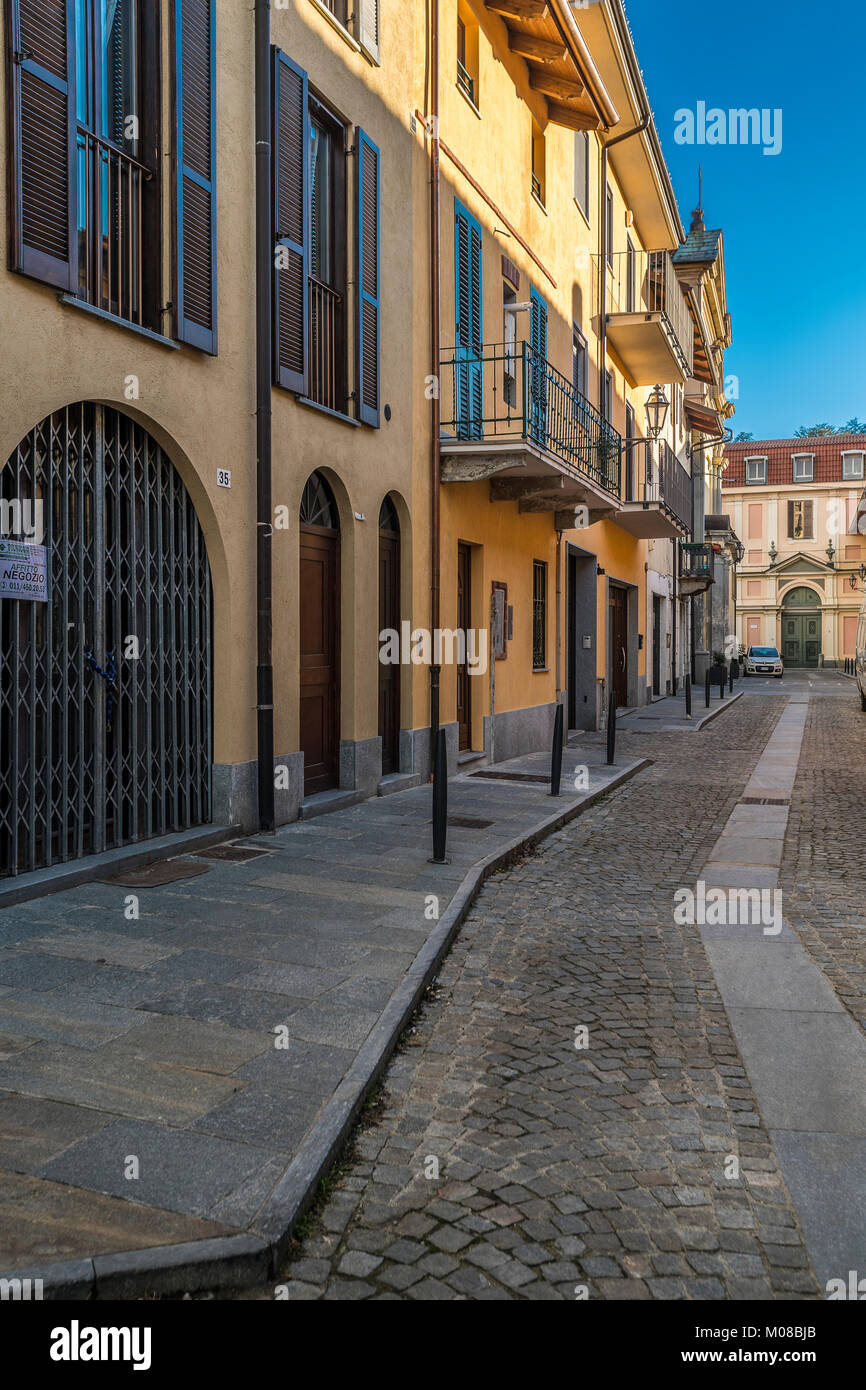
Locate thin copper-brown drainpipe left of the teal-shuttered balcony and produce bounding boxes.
[428,0,442,776]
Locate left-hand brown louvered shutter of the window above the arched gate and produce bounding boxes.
[7,0,78,291]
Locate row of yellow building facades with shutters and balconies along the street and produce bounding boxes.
[0,0,733,877]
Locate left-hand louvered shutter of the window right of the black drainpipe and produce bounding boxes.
[272,49,310,396]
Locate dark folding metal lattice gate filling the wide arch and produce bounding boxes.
[0,402,213,876]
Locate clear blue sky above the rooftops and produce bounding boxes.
[626,0,866,439]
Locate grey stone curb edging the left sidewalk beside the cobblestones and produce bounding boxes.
[0,756,650,1301]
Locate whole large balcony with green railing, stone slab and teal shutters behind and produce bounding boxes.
[439,339,623,517]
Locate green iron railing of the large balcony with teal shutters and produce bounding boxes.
[439,339,623,498]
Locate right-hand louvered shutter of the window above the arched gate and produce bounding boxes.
[174,0,217,354]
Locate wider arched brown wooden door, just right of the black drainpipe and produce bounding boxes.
[299,473,339,796]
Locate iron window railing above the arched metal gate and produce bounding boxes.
[78,125,152,325]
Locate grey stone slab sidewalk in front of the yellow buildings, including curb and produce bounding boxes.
[0,735,646,1297]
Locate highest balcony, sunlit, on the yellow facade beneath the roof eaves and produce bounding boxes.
[594,250,695,386]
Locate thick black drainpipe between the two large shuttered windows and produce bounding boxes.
[256,0,274,831]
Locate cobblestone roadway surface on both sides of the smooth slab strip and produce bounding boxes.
[237,682,863,1300]
